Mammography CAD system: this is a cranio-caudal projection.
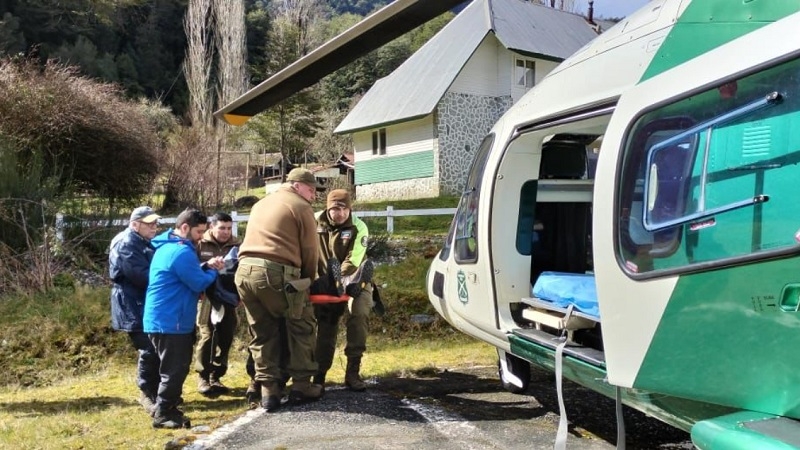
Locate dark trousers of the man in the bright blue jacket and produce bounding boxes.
[148,333,194,411]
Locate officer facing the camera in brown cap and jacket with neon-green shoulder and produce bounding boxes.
[314,189,373,392]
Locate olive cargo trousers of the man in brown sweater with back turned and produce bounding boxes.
[235,257,317,385]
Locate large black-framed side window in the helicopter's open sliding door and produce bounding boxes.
[617,56,800,273]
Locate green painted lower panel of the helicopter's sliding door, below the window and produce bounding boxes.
[634,257,800,418]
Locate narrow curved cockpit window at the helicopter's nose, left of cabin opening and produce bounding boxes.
[451,134,494,263]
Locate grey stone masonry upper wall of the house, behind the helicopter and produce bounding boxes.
[437,92,513,195]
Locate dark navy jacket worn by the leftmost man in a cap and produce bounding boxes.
[108,228,155,332]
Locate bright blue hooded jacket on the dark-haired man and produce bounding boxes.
[144,230,217,334]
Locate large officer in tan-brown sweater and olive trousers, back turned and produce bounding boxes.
[235,168,322,412]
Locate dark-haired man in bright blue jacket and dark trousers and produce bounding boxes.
[144,209,223,428]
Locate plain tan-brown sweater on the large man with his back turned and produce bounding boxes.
[239,184,319,279]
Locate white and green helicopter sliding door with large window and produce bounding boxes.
[593,14,800,417]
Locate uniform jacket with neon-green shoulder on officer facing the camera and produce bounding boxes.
[316,209,369,276]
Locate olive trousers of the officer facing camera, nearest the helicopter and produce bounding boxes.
[314,286,372,374]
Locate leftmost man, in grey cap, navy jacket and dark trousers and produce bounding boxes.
[108,206,161,415]
